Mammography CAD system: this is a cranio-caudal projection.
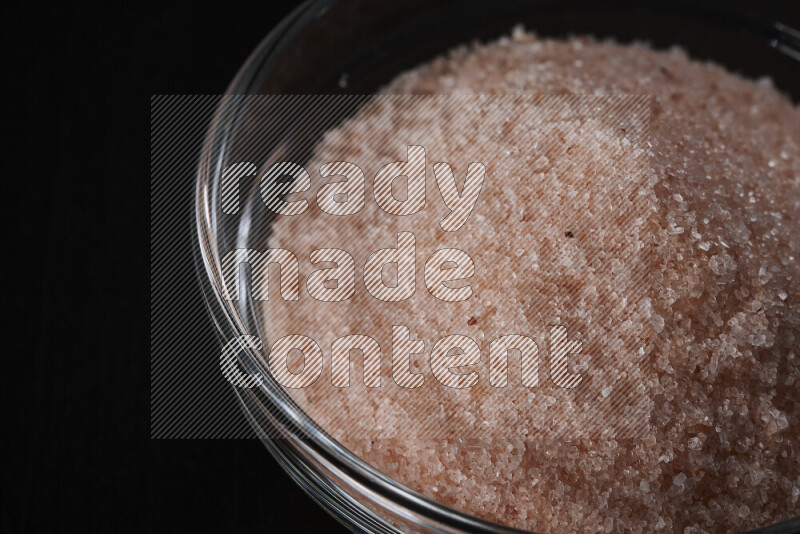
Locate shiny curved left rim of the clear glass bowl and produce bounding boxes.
[195,0,530,534]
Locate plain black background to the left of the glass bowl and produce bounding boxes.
[10,0,796,532]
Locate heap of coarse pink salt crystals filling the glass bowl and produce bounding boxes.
[260,31,800,532]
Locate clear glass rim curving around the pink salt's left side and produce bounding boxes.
[195,0,800,534]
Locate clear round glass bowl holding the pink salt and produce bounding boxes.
[196,0,800,533]
